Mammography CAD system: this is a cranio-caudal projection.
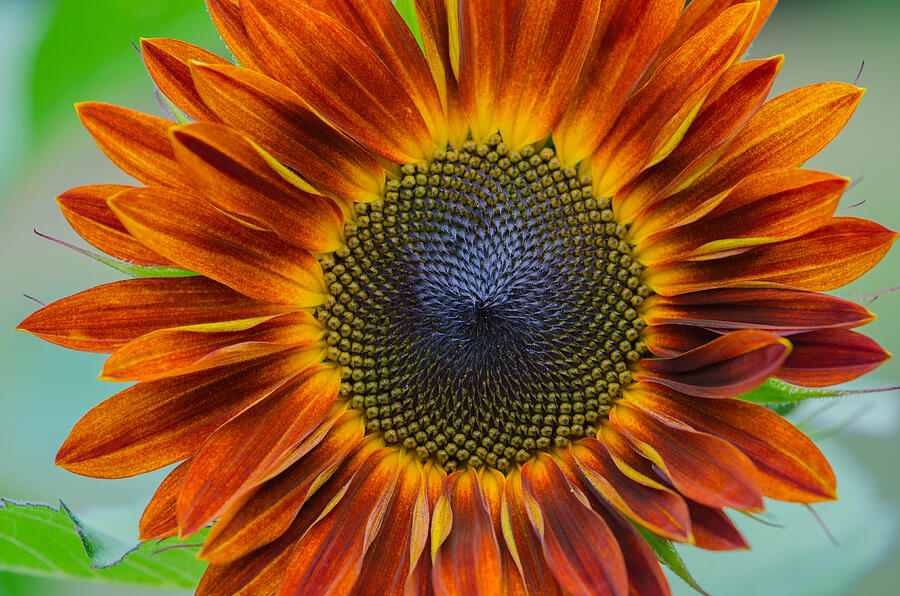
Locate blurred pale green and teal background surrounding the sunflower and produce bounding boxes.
[0,0,900,596]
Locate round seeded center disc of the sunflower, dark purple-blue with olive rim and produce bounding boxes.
[318,136,650,472]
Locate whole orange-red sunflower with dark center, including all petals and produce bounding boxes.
[15,0,897,596]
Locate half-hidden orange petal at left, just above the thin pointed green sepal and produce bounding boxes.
[56,184,172,267]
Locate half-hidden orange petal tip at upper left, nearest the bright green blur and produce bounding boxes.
[141,38,231,122]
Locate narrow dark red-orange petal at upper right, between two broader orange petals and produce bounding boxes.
[613,56,784,221]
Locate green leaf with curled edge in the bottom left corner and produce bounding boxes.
[0,499,206,589]
